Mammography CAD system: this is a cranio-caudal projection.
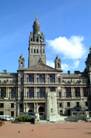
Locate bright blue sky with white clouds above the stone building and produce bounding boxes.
[0,0,91,72]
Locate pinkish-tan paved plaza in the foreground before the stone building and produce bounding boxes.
[0,122,91,138]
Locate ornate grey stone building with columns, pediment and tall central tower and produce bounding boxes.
[0,19,91,119]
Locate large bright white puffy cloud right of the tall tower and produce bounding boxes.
[47,36,85,60]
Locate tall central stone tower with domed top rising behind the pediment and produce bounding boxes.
[28,18,46,67]
